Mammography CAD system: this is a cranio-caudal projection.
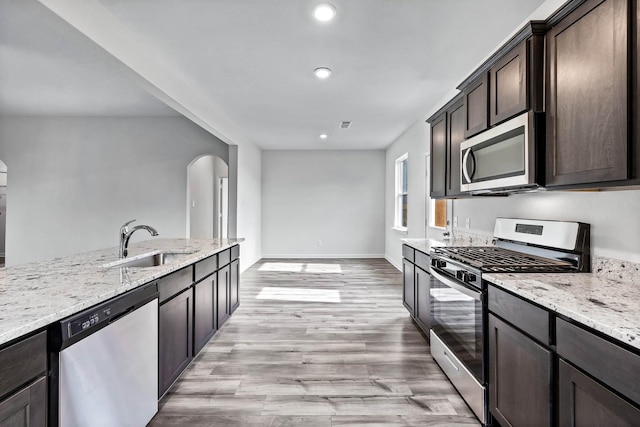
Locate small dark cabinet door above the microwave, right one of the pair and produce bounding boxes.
[489,40,528,126]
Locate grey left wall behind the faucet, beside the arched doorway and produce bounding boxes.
[0,117,229,265]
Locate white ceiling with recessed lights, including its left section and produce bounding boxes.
[0,0,543,149]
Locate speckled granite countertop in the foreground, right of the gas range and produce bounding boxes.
[482,273,640,350]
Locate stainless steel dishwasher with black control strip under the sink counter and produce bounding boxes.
[49,284,158,427]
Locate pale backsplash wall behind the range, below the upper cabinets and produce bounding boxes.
[453,190,640,262]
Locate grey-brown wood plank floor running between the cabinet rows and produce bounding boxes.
[150,259,479,427]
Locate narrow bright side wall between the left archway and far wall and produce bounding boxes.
[235,142,263,272]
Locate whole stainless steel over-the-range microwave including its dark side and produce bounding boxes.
[460,112,545,194]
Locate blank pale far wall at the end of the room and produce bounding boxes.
[262,150,385,258]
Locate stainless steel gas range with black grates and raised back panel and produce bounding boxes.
[430,218,591,424]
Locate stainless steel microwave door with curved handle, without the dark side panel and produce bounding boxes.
[460,113,532,192]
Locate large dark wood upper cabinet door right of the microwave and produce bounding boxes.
[546,0,629,186]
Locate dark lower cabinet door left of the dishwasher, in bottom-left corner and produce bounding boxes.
[0,377,47,427]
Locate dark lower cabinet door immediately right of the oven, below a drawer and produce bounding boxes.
[489,314,553,427]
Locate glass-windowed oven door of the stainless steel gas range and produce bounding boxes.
[430,267,484,384]
